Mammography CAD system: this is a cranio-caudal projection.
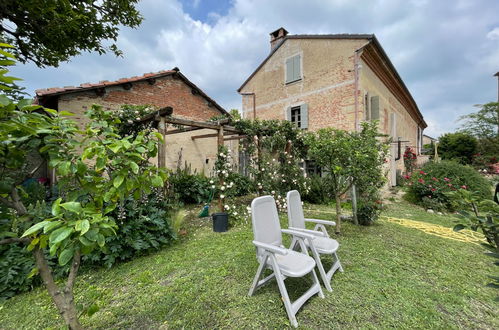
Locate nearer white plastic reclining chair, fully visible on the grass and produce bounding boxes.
[249,196,324,327]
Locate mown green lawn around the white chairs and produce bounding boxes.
[0,202,499,329]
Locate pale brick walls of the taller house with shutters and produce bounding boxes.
[241,39,426,187]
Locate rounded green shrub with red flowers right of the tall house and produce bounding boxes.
[406,161,492,210]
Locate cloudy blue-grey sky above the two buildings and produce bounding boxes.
[9,0,499,136]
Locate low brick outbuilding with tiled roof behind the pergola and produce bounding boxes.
[36,68,238,174]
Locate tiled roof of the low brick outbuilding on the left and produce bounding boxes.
[35,67,228,114]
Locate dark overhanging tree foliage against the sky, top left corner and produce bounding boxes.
[0,0,142,67]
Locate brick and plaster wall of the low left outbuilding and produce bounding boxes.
[58,76,237,175]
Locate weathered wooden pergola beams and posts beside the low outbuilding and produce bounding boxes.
[139,107,246,212]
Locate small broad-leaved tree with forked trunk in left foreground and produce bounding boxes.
[0,45,166,329]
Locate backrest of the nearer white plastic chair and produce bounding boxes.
[251,196,282,255]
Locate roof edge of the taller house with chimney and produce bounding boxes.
[237,33,426,127]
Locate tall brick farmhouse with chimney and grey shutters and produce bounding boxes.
[238,28,427,185]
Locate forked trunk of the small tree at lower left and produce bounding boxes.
[33,247,83,330]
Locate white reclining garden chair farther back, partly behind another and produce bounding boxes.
[287,190,343,291]
